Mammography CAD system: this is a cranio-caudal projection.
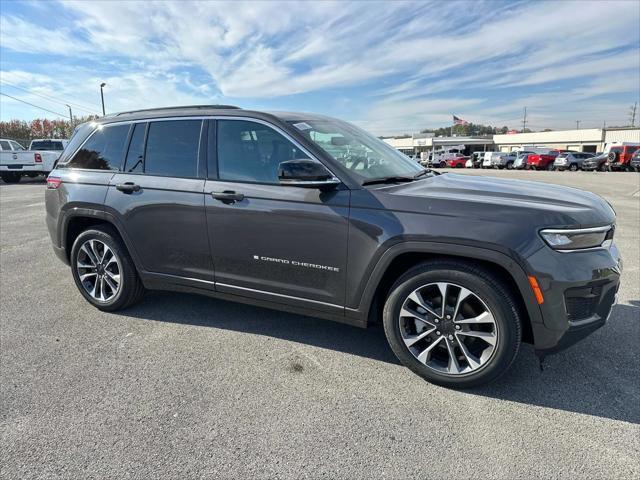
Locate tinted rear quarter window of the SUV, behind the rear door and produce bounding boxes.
[67,125,129,170]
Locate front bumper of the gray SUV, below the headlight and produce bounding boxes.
[528,243,622,353]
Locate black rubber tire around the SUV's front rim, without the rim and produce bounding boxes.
[383,260,522,388]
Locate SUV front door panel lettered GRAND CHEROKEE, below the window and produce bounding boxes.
[205,180,350,310]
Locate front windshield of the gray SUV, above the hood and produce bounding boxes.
[289,119,424,182]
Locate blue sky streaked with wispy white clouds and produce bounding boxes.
[0,0,640,135]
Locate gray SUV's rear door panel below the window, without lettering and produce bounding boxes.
[105,173,213,282]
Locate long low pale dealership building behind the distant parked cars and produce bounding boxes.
[383,127,640,155]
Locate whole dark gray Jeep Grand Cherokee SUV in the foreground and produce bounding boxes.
[46,106,621,387]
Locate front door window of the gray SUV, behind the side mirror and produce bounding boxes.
[217,120,309,184]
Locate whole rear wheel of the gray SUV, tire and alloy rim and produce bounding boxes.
[70,225,144,312]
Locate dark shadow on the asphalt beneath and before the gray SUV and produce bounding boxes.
[122,291,640,424]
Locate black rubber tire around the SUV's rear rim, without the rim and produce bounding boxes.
[70,224,145,312]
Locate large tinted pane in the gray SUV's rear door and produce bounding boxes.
[144,120,202,177]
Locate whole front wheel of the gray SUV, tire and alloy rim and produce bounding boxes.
[383,261,522,388]
